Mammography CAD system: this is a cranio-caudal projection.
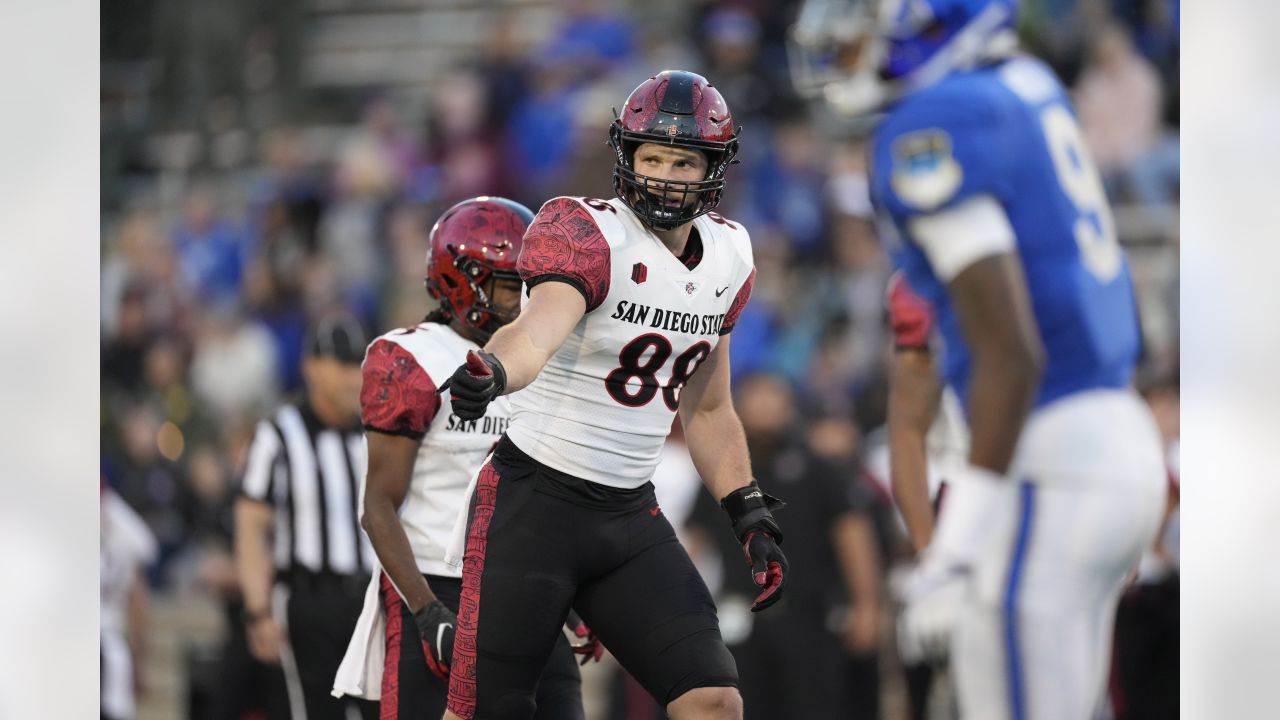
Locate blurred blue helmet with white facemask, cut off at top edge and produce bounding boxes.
[790,0,1018,115]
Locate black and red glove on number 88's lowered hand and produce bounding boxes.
[721,482,787,612]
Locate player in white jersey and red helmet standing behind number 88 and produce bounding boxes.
[335,197,590,720]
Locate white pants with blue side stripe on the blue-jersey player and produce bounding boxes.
[951,389,1167,720]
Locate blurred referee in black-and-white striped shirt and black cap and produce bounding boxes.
[236,315,378,720]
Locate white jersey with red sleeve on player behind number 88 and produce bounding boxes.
[360,323,511,578]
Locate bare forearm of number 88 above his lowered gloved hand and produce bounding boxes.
[681,402,751,502]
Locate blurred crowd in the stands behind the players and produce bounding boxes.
[101,0,1179,717]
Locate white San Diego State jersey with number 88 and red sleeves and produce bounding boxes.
[507,197,755,488]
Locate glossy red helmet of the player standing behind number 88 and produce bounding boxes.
[426,197,534,341]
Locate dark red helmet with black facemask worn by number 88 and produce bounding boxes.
[609,70,739,229]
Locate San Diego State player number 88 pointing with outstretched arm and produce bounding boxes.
[435,70,786,720]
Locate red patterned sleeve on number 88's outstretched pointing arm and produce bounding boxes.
[517,197,611,313]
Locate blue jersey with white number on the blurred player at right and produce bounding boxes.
[872,58,1140,406]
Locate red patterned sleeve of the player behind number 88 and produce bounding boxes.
[360,340,440,439]
